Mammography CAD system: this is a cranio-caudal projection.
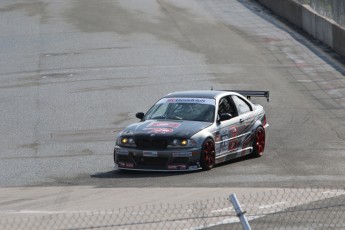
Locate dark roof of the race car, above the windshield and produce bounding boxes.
[164,90,232,99]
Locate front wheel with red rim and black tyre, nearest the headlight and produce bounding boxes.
[200,138,216,170]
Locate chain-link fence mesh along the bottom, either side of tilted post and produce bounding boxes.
[0,189,345,230]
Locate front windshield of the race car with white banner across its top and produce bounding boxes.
[144,98,215,122]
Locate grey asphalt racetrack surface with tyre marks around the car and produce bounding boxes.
[0,0,345,188]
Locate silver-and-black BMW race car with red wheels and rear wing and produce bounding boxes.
[114,90,269,171]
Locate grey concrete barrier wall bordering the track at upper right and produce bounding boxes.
[257,0,345,56]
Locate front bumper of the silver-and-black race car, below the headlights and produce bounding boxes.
[114,146,201,171]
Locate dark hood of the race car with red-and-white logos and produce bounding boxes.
[122,120,212,138]
